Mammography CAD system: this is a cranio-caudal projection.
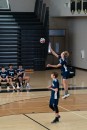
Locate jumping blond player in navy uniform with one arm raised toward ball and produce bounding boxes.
[47,47,70,99]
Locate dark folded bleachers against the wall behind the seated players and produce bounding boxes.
[0,0,49,70]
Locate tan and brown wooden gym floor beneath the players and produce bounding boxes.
[0,70,87,130]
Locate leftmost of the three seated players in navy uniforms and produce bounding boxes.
[0,67,10,91]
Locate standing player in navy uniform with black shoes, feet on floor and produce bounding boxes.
[48,72,60,123]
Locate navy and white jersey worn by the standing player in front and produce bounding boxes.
[51,79,59,99]
